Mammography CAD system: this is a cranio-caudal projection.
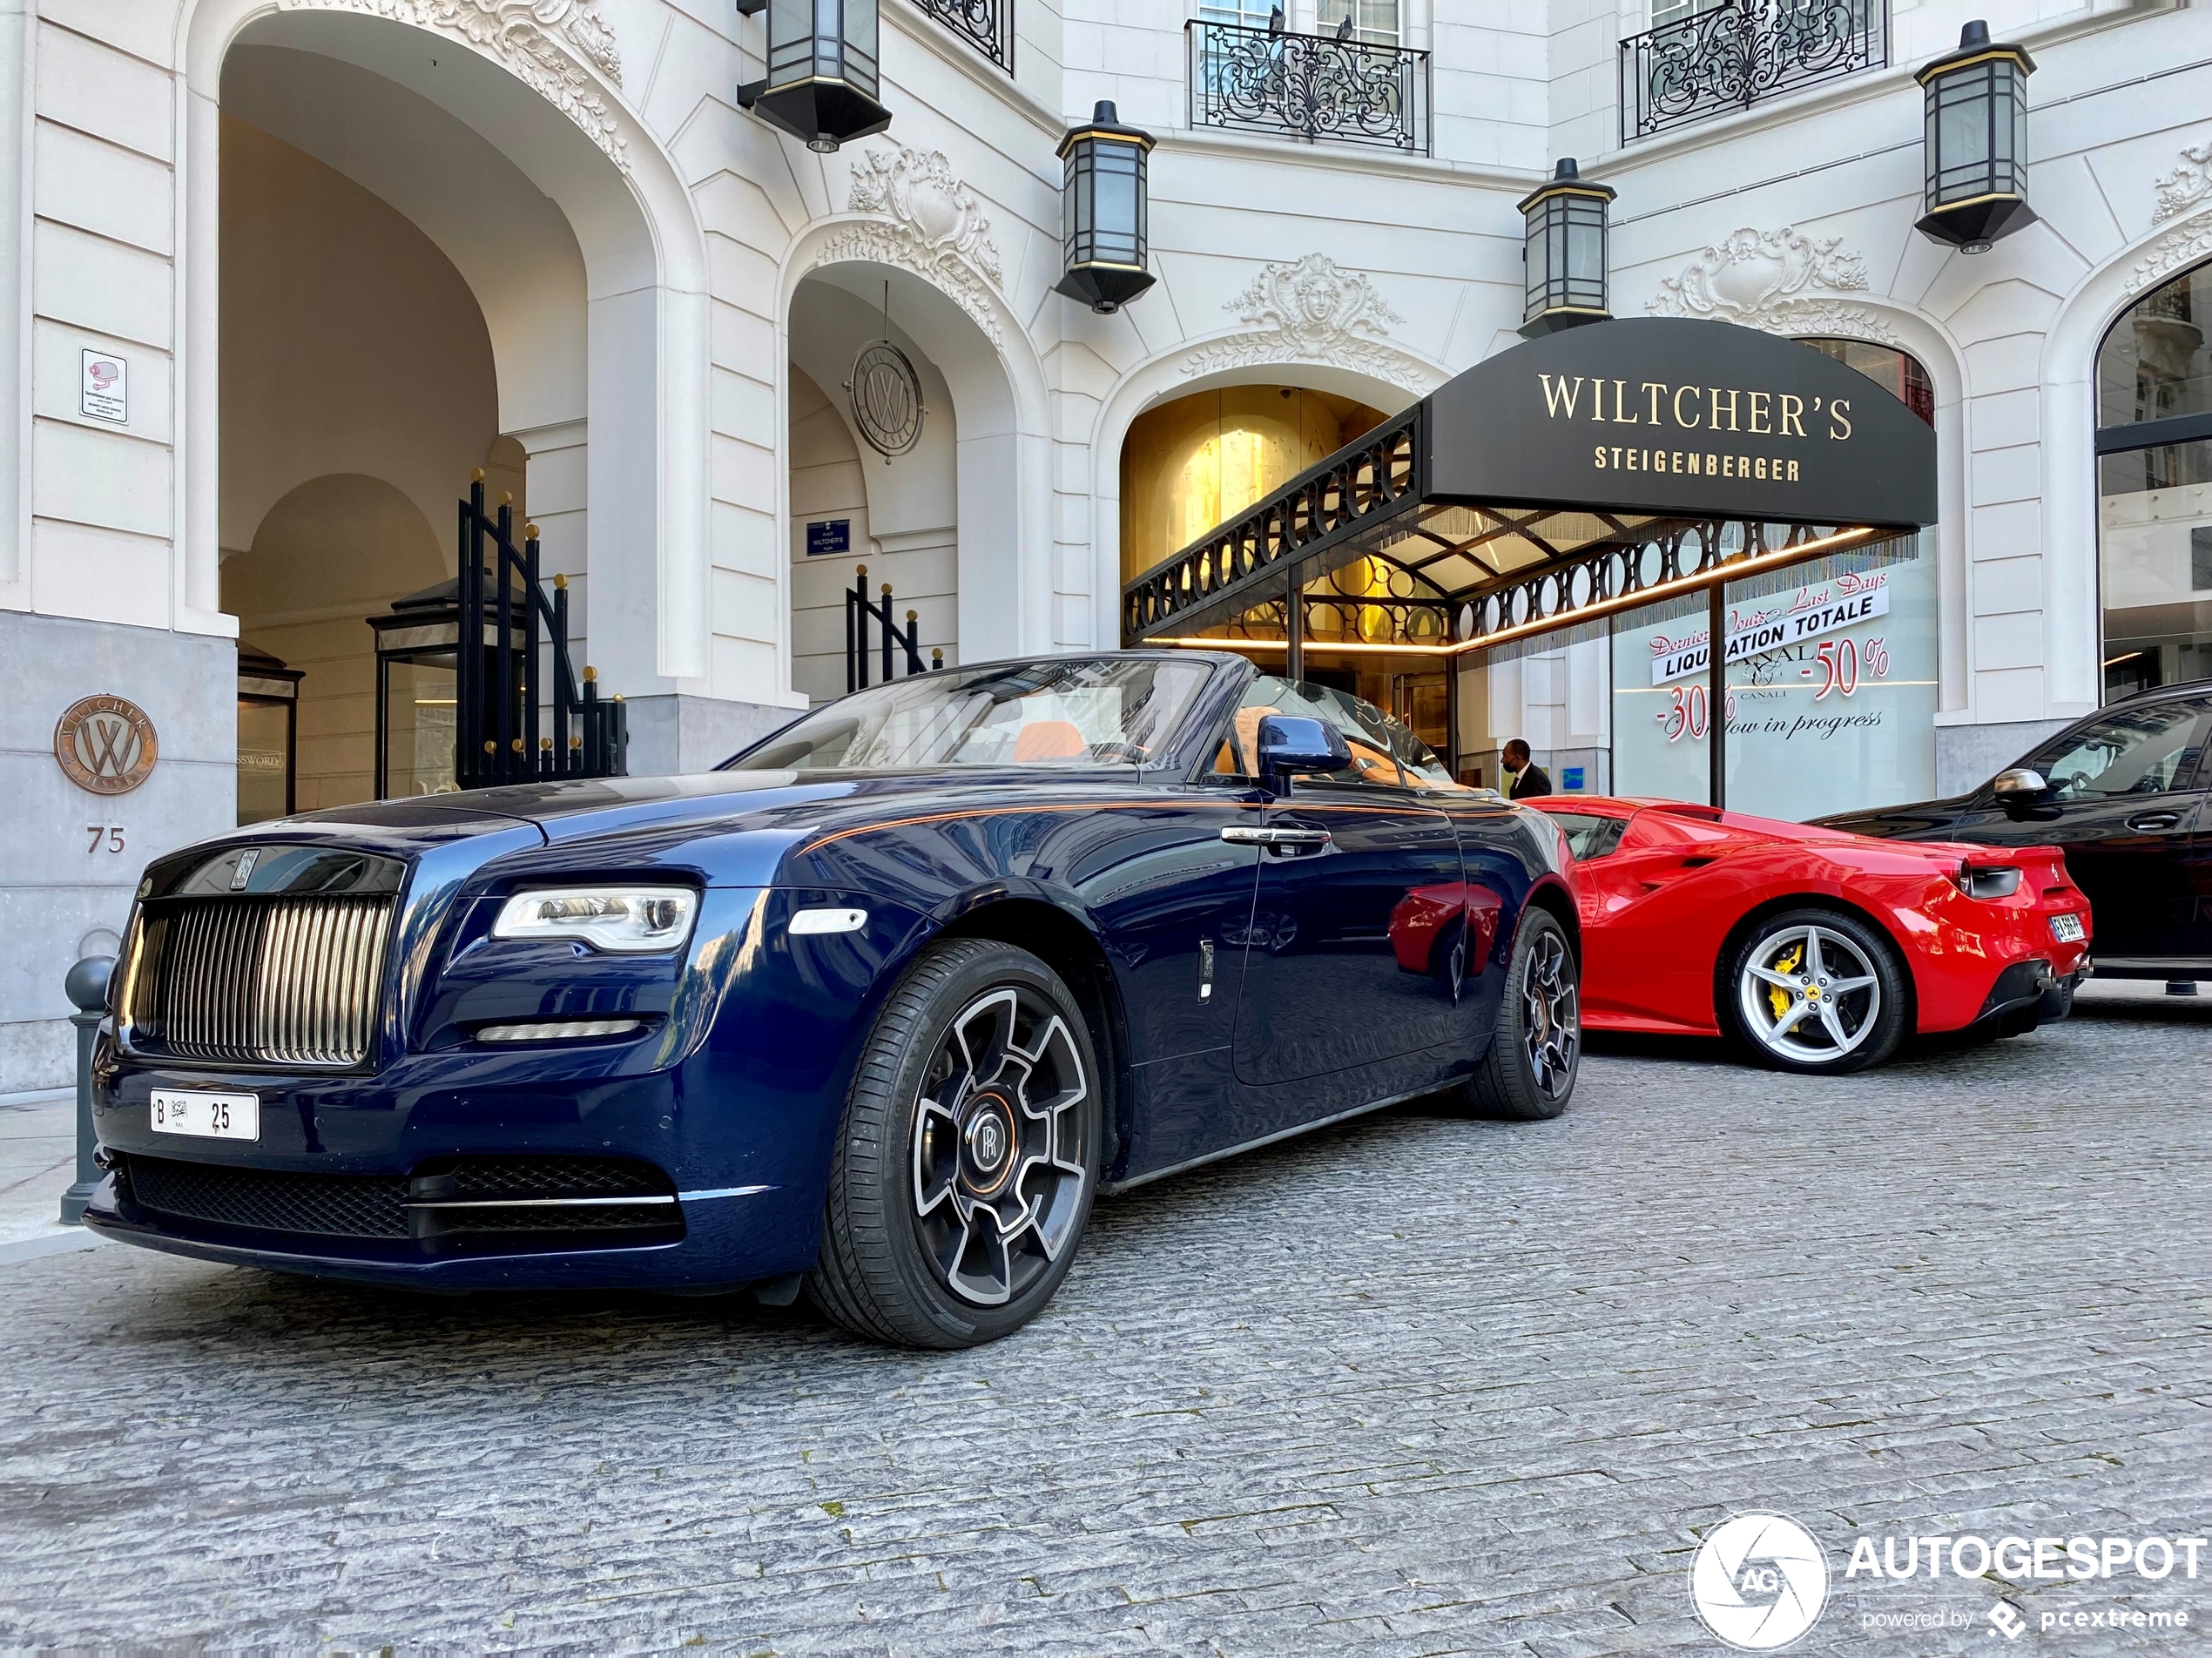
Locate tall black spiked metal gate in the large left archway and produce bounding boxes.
[454,471,631,789]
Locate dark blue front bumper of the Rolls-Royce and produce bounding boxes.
[84,1043,836,1289]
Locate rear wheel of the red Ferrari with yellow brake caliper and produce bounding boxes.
[1716,907,1913,1076]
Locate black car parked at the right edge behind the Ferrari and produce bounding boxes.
[1820,681,2212,980]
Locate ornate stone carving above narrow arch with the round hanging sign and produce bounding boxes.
[814,151,1007,347]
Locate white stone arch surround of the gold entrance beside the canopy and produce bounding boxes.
[1090,351,1451,648]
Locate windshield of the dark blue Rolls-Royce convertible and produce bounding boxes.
[724,657,1214,772]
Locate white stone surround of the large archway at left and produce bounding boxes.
[179,0,712,697]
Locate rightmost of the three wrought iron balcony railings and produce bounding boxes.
[1622,0,1889,144]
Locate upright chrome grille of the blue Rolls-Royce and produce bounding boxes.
[122,893,394,1066]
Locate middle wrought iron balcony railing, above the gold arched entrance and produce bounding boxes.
[1184,20,1429,155]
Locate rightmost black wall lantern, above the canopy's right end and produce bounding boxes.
[1916,20,2035,254]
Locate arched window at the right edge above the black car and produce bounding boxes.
[2097,263,2212,701]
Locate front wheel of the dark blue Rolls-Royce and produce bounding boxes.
[806,940,1103,1349]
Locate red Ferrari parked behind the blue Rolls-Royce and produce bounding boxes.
[1527,796,2090,1072]
